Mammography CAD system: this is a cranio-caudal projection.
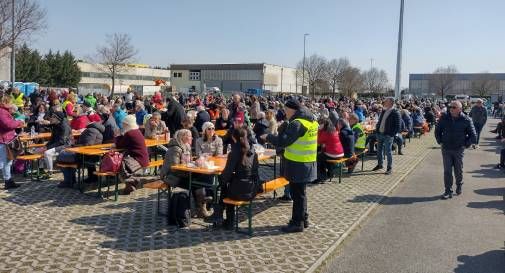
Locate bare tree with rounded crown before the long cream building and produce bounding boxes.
[93,33,137,98]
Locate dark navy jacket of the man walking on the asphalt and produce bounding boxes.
[435,113,477,150]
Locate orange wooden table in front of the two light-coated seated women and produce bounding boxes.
[172,149,277,224]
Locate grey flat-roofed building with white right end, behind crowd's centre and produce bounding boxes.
[170,63,302,94]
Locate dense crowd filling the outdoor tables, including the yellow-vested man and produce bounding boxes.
[0,83,498,232]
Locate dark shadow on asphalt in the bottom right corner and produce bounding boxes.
[454,250,505,273]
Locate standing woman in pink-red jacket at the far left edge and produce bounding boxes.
[0,94,23,190]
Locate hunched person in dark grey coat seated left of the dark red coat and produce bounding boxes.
[57,119,105,188]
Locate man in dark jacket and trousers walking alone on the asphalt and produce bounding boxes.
[435,100,477,199]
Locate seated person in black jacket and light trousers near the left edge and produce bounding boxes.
[39,106,72,179]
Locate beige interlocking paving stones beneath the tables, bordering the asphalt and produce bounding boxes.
[0,135,434,272]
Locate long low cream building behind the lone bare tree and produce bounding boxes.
[77,62,170,95]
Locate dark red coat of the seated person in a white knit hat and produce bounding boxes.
[115,129,149,167]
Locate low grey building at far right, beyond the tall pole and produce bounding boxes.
[409,73,505,101]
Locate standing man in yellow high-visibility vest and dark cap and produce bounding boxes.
[261,99,319,233]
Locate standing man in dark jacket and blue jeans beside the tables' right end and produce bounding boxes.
[373,98,400,175]
